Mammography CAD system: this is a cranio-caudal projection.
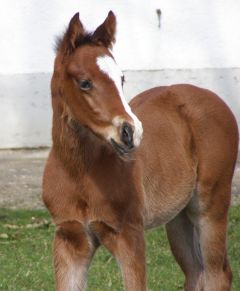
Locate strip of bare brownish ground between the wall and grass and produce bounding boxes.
[0,149,240,209]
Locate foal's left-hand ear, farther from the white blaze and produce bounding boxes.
[61,13,84,54]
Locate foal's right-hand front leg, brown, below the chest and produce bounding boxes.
[93,223,147,291]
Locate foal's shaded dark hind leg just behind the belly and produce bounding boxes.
[166,210,203,291]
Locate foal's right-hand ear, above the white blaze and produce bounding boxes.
[92,11,116,48]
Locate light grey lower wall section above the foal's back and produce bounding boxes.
[124,68,240,124]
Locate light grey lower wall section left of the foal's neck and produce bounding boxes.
[0,73,52,148]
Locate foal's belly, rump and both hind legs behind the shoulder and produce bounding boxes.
[132,85,238,291]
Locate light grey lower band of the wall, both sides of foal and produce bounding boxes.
[0,68,240,148]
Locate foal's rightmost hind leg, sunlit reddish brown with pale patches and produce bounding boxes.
[190,182,232,291]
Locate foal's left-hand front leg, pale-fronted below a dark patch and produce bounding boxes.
[54,221,96,291]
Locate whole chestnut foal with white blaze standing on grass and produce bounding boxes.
[43,12,238,291]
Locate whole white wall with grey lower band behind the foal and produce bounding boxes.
[0,0,240,148]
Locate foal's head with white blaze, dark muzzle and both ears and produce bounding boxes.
[54,11,142,155]
